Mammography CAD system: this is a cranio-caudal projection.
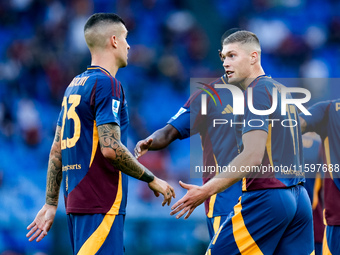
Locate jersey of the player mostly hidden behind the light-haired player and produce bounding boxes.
[168,76,242,218]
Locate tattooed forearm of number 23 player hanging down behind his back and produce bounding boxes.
[46,127,63,206]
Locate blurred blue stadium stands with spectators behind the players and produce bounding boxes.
[0,0,340,255]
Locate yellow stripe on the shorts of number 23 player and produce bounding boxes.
[77,215,116,255]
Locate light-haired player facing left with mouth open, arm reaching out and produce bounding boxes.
[171,31,314,255]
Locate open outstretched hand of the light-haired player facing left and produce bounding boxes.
[170,181,209,220]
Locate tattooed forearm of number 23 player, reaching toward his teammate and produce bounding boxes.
[98,124,154,182]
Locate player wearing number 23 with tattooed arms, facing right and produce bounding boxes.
[27,13,175,255]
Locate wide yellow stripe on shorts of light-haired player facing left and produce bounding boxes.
[231,199,263,255]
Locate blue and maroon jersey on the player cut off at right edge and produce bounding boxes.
[300,99,340,226]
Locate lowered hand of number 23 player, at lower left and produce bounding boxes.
[26,204,57,242]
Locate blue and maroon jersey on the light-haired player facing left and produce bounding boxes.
[235,75,305,191]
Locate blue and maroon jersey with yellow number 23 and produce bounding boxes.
[58,66,129,215]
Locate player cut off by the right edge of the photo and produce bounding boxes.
[300,99,340,255]
